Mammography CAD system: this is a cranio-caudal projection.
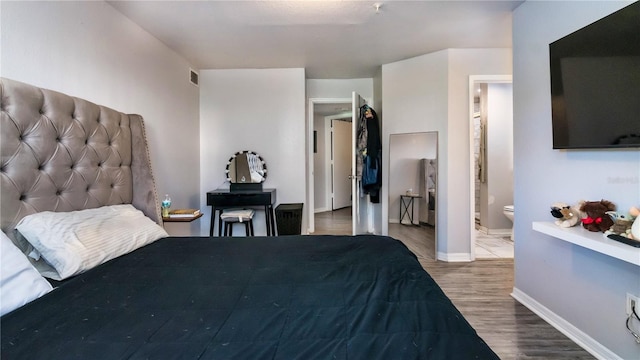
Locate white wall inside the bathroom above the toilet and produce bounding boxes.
[482,83,513,233]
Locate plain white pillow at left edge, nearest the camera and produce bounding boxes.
[0,231,52,316]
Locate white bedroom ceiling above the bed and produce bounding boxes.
[108,0,523,79]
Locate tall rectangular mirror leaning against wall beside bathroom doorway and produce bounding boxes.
[388,131,438,259]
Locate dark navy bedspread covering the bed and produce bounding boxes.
[0,235,498,359]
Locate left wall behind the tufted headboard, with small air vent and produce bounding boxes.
[0,1,200,235]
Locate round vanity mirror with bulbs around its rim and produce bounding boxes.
[226,150,267,184]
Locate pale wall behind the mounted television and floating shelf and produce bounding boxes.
[513,1,640,359]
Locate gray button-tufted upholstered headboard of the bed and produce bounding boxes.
[0,78,162,236]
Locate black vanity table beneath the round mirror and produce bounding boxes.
[207,189,276,236]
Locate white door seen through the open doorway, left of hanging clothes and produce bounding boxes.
[331,120,353,210]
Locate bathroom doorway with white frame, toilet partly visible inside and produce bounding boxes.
[469,76,514,259]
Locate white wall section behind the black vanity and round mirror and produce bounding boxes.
[200,69,307,235]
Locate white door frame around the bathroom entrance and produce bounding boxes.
[467,75,513,261]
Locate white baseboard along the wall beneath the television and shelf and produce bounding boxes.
[511,287,622,360]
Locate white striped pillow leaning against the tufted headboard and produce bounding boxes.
[16,204,169,280]
